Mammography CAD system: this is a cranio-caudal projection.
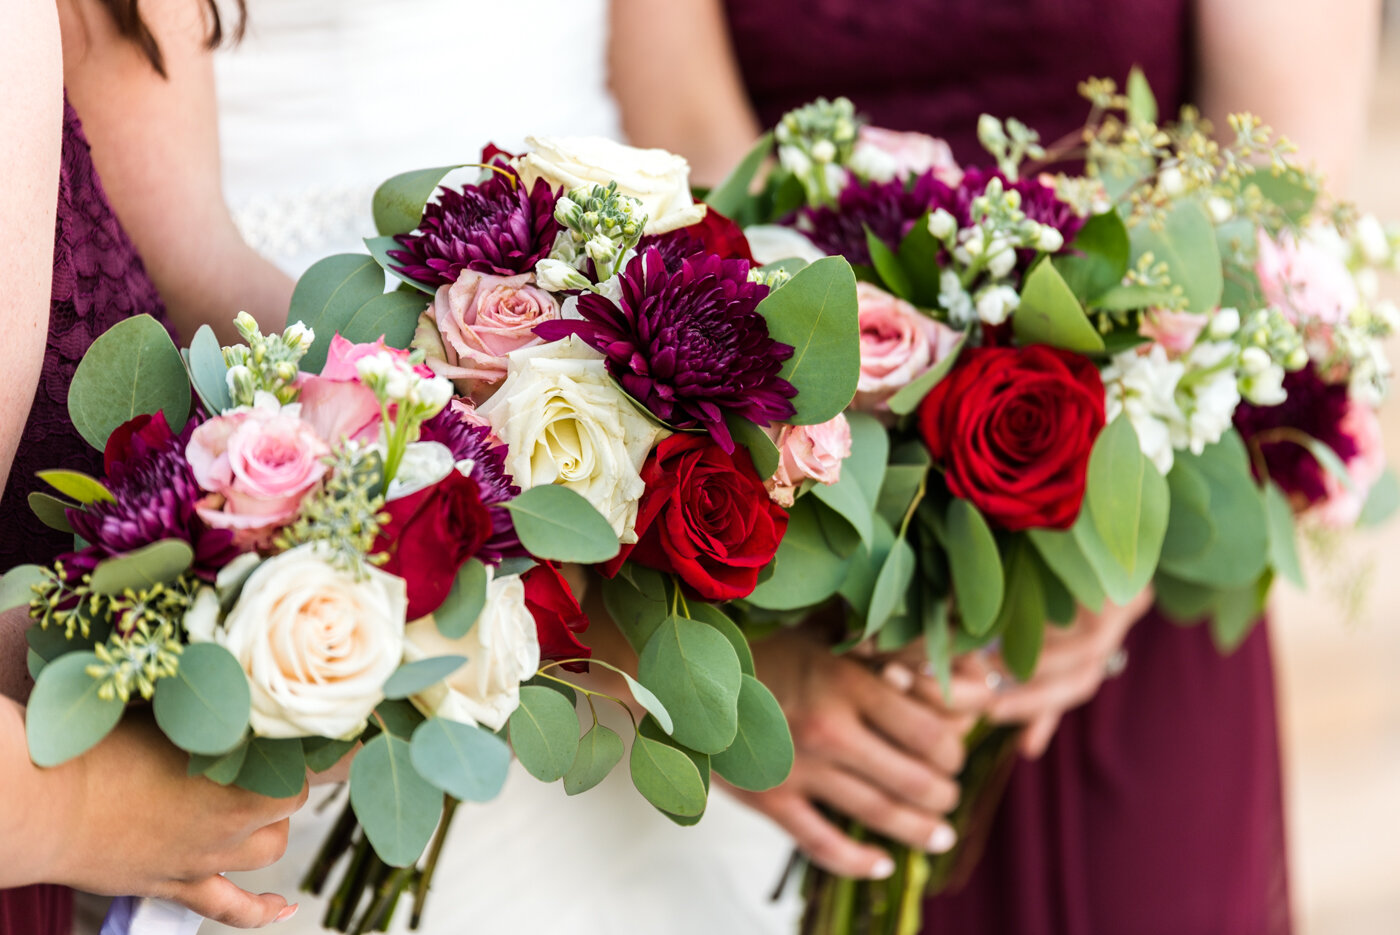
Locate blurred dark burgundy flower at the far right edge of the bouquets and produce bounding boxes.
[1235,367,1357,504]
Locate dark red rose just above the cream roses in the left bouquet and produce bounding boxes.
[374,470,491,620]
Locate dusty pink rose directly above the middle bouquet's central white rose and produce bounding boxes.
[424,270,559,391]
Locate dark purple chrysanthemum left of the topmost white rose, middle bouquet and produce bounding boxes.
[389,169,560,286]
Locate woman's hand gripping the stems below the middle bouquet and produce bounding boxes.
[735,633,977,878]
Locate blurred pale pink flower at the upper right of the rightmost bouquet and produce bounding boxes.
[1254,230,1361,332]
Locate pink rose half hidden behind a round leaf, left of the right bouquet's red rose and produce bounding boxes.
[853,283,960,412]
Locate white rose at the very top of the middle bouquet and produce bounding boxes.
[515,136,706,234]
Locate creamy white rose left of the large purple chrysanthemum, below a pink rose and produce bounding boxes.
[476,336,666,543]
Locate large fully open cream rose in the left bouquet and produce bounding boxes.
[203,544,409,738]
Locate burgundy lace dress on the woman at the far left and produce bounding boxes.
[0,102,165,935]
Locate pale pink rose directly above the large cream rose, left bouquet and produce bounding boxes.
[185,406,330,549]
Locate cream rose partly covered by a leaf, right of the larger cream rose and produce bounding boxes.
[405,575,539,731]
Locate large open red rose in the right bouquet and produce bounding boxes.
[918,344,1103,529]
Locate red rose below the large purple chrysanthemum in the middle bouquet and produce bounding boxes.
[605,434,787,600]
